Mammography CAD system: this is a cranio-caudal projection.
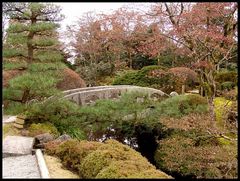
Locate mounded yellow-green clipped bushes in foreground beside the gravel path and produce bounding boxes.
[54,140,171,178]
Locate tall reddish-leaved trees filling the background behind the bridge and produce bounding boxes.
[66,3,238,123]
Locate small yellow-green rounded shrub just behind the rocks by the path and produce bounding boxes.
[28,122,59,137]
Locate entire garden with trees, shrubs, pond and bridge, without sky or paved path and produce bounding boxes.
[2,2,238,179]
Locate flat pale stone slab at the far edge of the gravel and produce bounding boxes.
[3,136,34,157]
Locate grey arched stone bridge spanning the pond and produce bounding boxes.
[63,85,169,105]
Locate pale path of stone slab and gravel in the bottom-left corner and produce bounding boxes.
[3,136,41,178]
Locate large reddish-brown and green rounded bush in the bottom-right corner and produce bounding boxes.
[155,132,237,178]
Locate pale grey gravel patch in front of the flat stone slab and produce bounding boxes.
[3,155,41,178]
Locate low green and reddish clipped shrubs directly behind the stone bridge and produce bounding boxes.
[113,65,197,94]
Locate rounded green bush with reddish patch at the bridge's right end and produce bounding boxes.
[157,95,208,117]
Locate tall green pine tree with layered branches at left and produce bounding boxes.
[3,3,65,103]
